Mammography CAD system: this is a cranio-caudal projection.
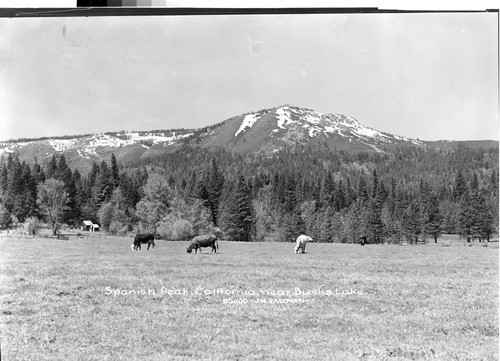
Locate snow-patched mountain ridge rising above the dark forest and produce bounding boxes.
[0,104,498,172]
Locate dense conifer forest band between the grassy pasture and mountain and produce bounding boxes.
[0,145,498,243]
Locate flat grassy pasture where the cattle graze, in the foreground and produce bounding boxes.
[0,235,499,360]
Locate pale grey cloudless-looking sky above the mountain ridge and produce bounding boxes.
[0,13,499,140]
